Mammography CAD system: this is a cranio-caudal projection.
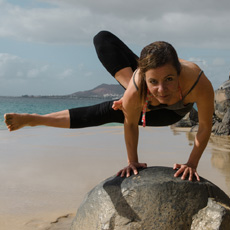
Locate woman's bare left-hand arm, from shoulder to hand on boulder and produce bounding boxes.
[117,73,147,177]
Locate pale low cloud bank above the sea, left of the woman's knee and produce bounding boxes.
[0,53,108,96]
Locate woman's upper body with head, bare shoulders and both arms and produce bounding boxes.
[118,38,214,180]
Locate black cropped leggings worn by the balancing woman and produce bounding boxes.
[69,31,182,128]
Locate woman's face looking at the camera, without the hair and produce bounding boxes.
[145,64,179,104]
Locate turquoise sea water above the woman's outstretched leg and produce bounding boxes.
[0,97,116,129]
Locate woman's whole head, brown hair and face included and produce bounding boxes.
[138,41,181,105]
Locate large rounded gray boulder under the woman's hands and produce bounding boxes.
[71,167,230,230]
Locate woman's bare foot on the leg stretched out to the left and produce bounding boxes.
[4,113,33,131]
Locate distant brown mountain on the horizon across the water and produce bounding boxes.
[67,84,125,98]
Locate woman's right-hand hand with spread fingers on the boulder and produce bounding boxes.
[173,164,200,181]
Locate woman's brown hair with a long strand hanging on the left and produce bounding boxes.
[138,41,181,102]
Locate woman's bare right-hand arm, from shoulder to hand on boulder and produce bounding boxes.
[174,73,214,180]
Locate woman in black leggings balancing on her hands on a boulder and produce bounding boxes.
[5,31,214,181]
